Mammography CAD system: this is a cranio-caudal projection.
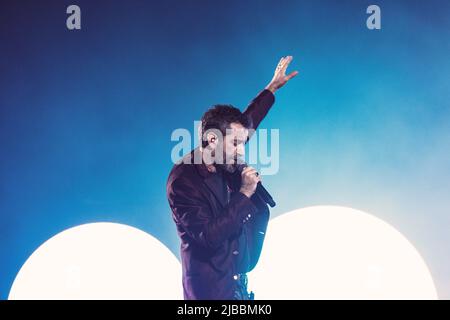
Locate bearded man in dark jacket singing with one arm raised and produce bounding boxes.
[167,56,298,300]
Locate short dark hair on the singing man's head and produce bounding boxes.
[200,104,252,148]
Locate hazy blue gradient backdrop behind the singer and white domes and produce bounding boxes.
[0,0,450,299]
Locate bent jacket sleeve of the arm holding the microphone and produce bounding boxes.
[168,178,257,249]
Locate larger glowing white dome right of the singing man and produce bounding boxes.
[249,206,438,299]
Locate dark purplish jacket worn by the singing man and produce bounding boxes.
[167,90,274,300]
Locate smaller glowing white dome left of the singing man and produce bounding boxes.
[9,223,183,299]
